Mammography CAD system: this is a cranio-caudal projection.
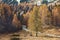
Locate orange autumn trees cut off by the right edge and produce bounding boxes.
[52,6,60,25]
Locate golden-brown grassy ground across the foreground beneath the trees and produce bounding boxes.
[0,29,60,40]
